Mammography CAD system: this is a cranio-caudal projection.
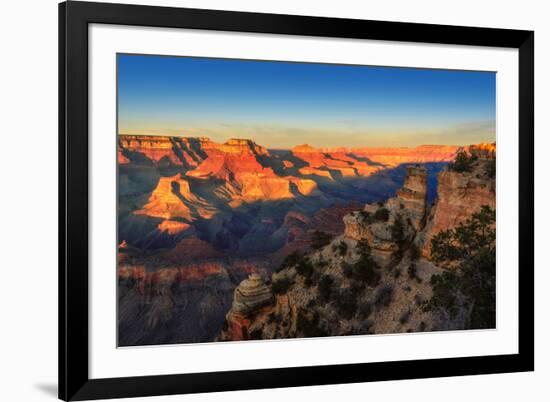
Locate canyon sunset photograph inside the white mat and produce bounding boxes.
[117,54,496,347]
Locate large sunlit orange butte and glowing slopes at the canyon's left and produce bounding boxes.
[119,136,317,209]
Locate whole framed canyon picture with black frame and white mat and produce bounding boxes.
[59,1,534,400]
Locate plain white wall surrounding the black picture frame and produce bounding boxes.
[0,0,550,402]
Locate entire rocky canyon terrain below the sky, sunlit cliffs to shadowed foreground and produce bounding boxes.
[117,135,496,346]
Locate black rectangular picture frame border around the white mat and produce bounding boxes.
[59,1,534,400]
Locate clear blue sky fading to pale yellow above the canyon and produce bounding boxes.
[118,55,496,148]
